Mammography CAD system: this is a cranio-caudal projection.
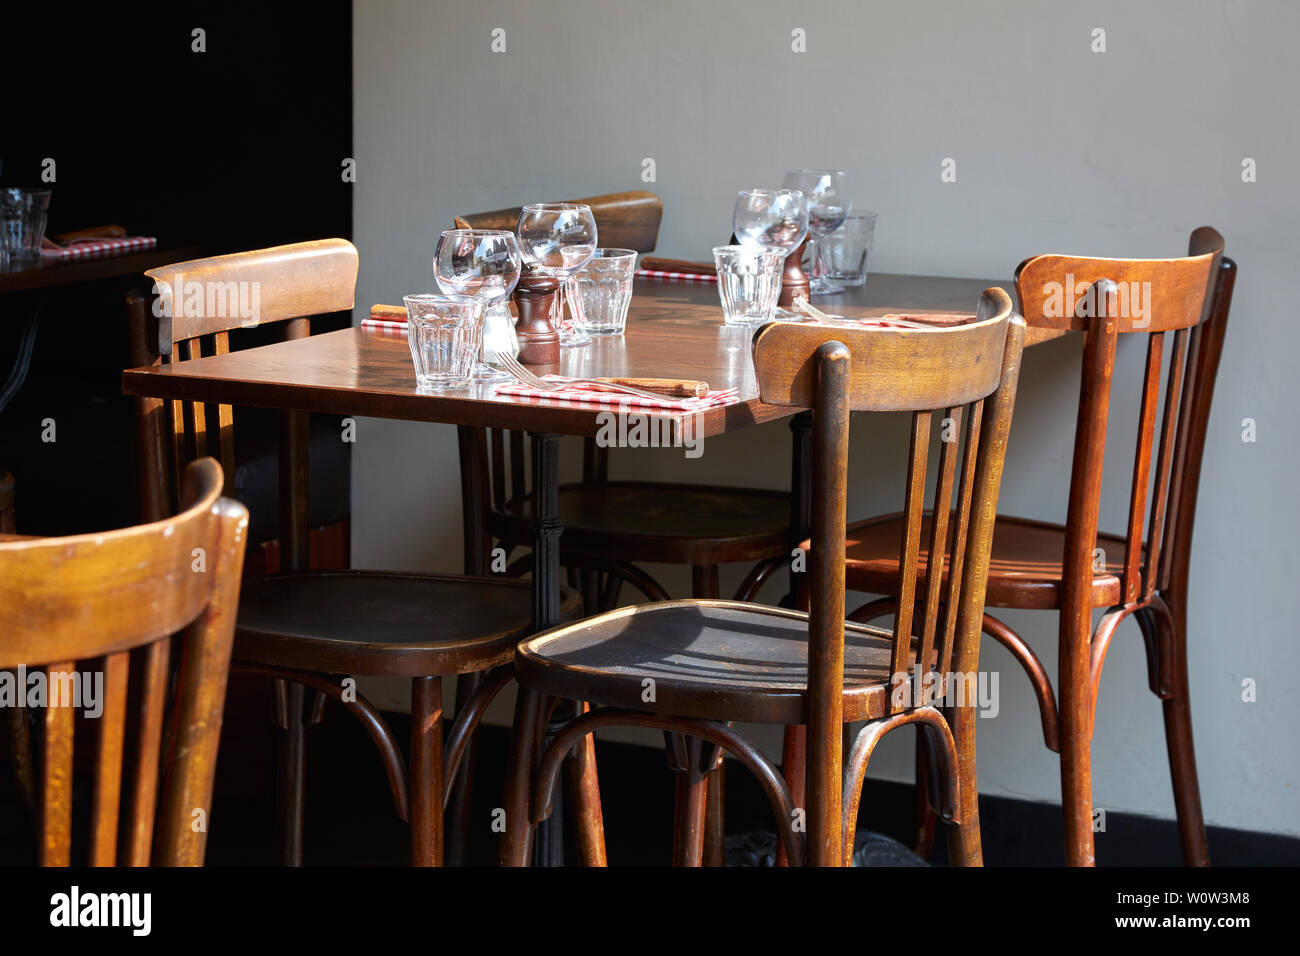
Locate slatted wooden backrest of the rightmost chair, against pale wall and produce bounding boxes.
[1015,226,1236,615]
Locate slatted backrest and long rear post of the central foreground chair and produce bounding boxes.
[754,287,1026,865]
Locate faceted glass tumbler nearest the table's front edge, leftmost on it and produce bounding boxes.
[402,294,484,392]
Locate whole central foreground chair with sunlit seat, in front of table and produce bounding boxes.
[502,289,1024,866]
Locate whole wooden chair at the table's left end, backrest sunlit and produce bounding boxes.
[127,239,579,865]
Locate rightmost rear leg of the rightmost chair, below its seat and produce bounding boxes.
[1154,596,1210,866]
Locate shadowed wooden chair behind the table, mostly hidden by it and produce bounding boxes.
[456,191,790,865]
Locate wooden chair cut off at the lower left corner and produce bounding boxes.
[0,459,248,866]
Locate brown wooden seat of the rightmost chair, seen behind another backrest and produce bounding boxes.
[826,512,1125,610]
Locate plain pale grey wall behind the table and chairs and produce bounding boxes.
[354,0,1300,834]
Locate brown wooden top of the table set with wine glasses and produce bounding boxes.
[122,274,1062,438]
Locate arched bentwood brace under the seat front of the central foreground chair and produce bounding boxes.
[530,708,803,866]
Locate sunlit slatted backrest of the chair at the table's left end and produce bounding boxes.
[126,239,358,570]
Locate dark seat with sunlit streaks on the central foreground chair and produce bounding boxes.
[515,601,910,724]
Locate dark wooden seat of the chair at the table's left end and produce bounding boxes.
[234,571,581,676]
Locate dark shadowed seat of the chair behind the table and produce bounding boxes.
[490,481,790,564]
